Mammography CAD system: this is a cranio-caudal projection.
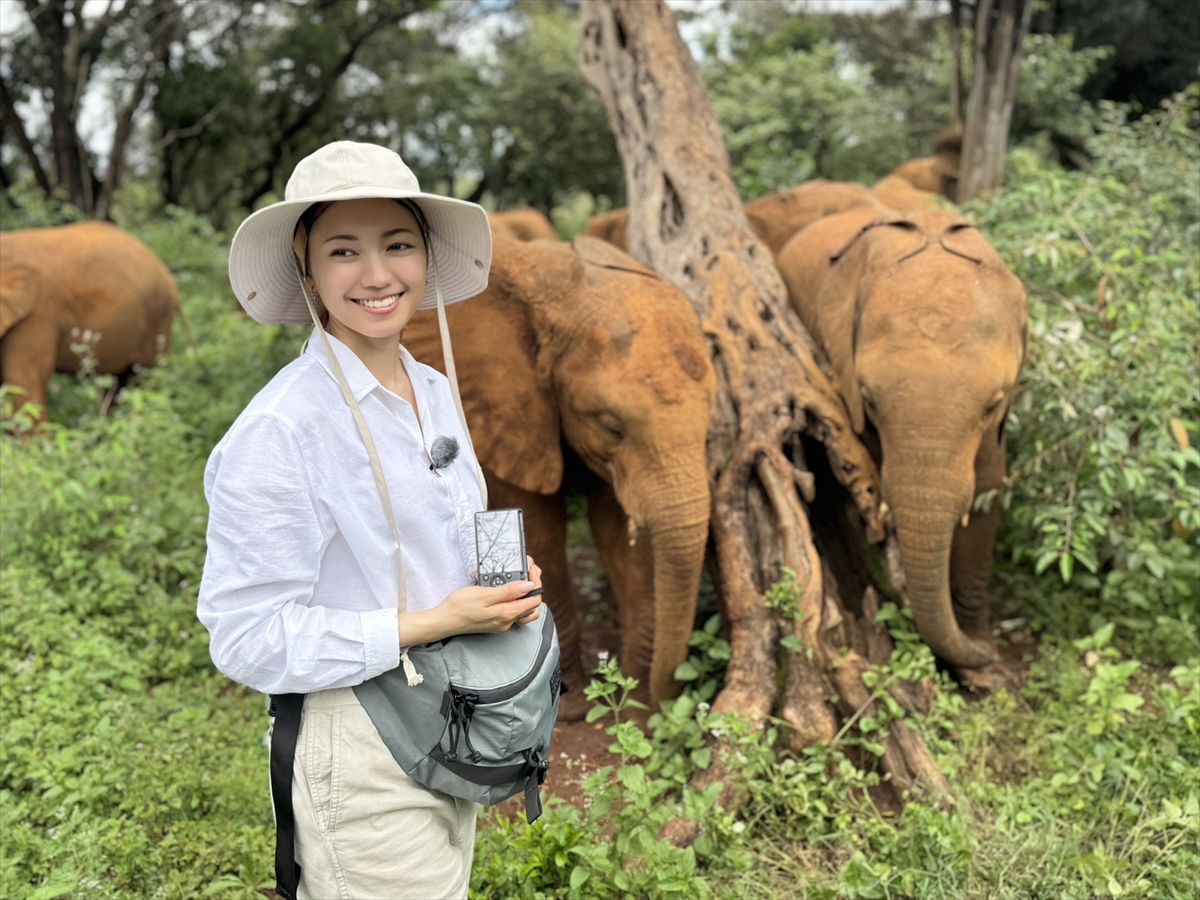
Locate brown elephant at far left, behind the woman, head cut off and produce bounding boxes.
[0,222,179,409]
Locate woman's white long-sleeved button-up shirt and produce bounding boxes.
[198,334,482,694]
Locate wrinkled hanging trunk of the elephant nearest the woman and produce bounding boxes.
[640,487,709,707]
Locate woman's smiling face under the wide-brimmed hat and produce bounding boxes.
[308,199,425,343]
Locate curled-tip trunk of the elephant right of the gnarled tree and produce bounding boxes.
[883,472,997,668]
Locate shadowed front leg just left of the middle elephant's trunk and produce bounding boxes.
[588,485,654,696]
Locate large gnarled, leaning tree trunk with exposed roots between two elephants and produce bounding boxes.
[580,0,946,840]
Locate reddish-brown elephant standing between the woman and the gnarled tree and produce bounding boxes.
[404,234,716,718]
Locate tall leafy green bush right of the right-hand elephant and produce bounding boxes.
[972,88,1200,661]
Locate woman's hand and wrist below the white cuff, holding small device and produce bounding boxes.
[396,557,541,647]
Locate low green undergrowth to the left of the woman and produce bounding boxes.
[0,190,300,898]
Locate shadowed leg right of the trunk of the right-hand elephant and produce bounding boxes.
[950,431,1006,640]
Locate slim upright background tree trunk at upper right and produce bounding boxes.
[958,0,1033,203]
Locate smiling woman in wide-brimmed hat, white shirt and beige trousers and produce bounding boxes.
[198,142,541,898]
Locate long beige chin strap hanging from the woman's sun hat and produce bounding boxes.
[292,228,487,688]
